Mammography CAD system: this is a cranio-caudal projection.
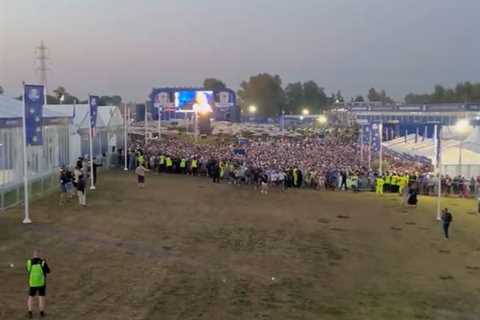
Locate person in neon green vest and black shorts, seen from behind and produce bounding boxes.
[27,250,50,319]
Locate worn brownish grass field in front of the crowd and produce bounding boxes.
[0,172,480,320]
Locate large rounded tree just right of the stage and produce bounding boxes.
[238,73,285,117]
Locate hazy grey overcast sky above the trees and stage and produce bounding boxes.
[0,0,480,101]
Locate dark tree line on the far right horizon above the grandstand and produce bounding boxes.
[405,81,480,104]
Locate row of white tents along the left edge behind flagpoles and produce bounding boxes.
[0,95,124,187]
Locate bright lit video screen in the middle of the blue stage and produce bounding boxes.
[175,90,215,112]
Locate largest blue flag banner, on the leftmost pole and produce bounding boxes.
[24,85,45,146]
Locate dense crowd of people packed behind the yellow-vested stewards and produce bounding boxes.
[118,129,458,195]
